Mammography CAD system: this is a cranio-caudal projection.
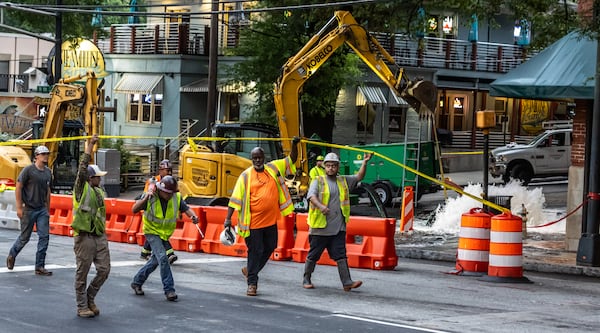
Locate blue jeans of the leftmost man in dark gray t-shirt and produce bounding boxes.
[9,207,50,269]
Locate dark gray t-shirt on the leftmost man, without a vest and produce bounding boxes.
[17,164,52,209]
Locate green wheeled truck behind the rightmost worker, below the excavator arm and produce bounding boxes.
[339,141,439,205]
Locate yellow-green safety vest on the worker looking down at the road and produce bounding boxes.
[143,192,181,240]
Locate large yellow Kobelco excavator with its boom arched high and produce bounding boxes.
[179,11,437,207]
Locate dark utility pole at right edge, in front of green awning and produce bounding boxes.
[577,0,600,267]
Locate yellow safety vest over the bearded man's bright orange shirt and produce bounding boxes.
[229,156,296,238]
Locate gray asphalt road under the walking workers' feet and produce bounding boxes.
[0,215,600,333]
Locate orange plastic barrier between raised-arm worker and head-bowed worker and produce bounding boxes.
[104,198,141,243]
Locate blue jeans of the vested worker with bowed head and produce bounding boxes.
[133,235,175,294]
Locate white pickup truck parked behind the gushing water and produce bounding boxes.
[489,121,573,185]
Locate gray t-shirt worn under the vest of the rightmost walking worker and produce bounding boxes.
[306,176,358,236]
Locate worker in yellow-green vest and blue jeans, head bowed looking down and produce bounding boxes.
[131,176,198,302]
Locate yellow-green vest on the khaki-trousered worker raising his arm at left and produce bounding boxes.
[71,182,106,235]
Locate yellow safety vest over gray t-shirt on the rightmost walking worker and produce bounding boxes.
[307,176,350,229]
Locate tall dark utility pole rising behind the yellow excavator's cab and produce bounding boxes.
[206,0,219,128]
